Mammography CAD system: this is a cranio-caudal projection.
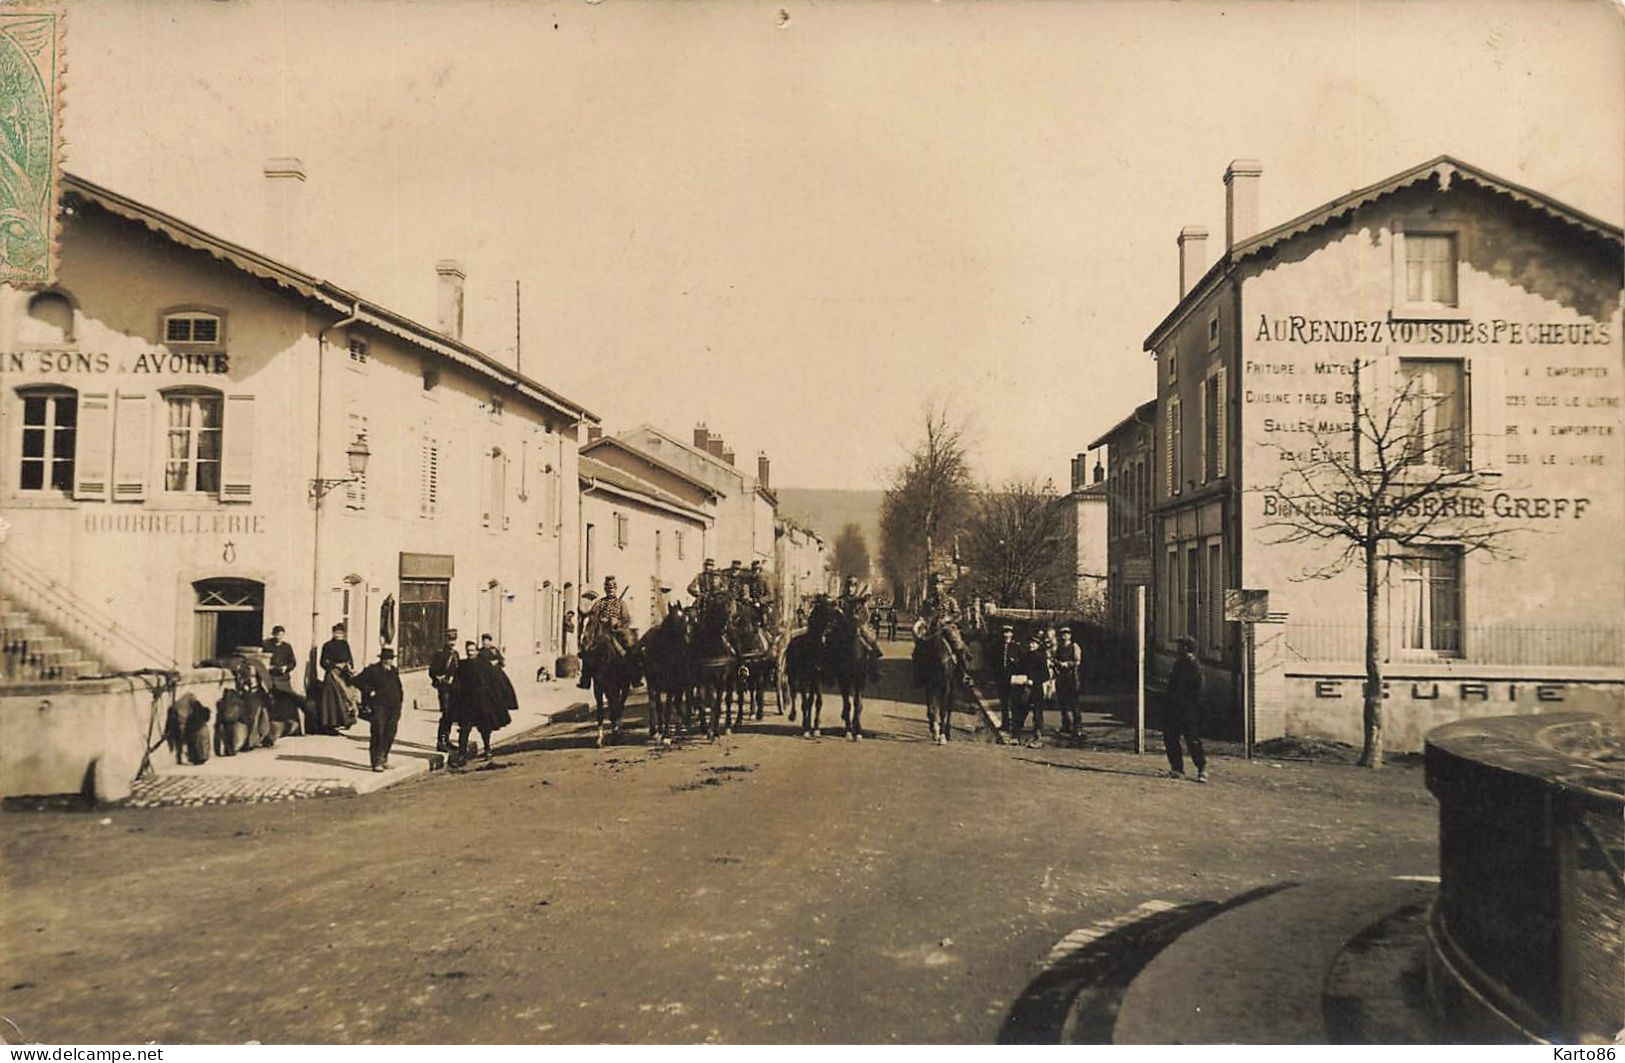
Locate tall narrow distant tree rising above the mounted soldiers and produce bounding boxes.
[881,398,973,600]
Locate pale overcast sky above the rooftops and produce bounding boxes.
[65,0,1625,488]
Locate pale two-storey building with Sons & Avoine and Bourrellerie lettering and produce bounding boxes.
[0,164,596,675]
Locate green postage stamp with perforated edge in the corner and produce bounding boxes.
[0,3,63,286]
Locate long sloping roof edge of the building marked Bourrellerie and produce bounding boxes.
[62,174,600,423]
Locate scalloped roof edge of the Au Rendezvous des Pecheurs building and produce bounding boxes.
[1144,154,1625,351]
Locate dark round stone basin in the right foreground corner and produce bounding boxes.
[1427,709,1625,1043]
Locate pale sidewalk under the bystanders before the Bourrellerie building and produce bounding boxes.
[124,671,592,808]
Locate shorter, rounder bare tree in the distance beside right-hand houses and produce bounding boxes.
[959,479,1071,606]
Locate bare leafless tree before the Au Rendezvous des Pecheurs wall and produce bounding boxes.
[1259,361,1521,767]
